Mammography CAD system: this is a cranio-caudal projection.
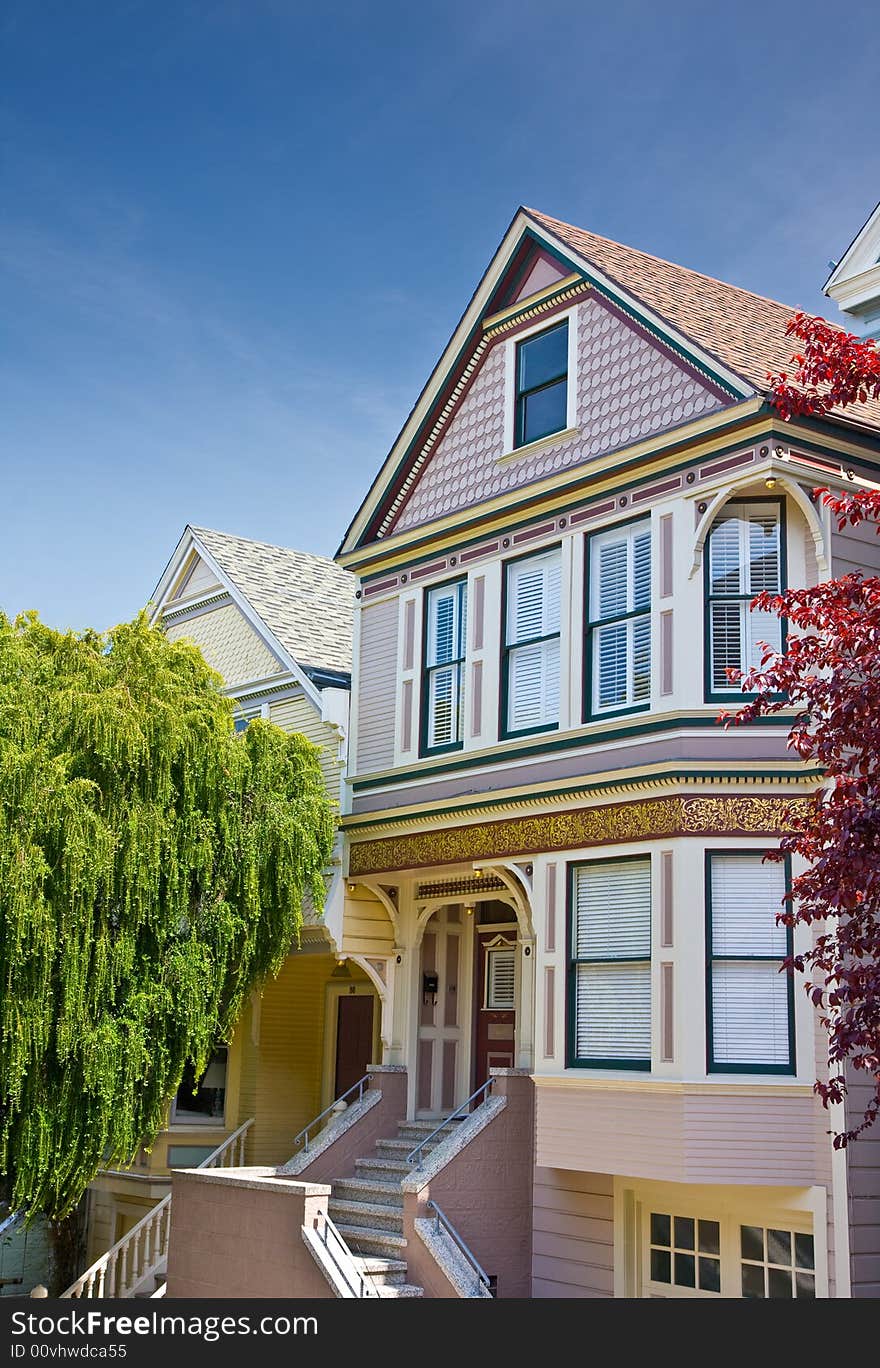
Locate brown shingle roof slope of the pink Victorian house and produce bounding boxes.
[526,209,880,427]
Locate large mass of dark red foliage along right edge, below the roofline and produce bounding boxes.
[721,491,880,1148]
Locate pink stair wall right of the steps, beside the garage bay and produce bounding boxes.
[404,1071,535,1297]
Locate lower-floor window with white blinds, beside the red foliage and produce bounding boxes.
[706,851,794,1074]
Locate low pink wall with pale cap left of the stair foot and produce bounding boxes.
[167,1168,334,1298]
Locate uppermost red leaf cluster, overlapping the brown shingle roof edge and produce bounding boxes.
[768,313,880,419]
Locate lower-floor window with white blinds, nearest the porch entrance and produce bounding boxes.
[568,855,651,1068]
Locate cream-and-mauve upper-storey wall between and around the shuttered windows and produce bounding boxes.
[347,479,818,792]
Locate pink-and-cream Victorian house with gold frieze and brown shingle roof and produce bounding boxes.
[331,209,880,1300]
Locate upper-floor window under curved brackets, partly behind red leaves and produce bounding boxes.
[705,501,784,694]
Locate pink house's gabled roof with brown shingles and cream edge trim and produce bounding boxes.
[337,208,880,554]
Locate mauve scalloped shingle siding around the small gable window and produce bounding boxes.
[396,300,723,531]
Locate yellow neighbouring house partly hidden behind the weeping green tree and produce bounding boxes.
[74,527,394,1274]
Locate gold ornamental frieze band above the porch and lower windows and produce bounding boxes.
[349,793,810,876]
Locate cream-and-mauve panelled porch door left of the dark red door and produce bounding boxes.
[416,906,472,1116]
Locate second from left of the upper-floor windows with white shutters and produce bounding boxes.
[504,547,561,736]
